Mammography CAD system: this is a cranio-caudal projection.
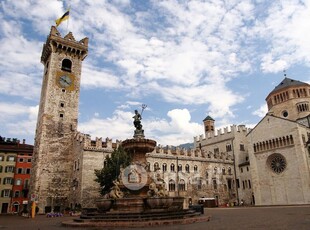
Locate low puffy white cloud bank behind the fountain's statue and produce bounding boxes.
[78,109,203,145]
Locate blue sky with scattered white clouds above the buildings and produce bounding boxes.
[0,0,310,146]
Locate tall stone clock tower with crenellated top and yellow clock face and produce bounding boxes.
[30,26,88,213]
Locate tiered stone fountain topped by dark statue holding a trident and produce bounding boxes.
[63,105,209,227]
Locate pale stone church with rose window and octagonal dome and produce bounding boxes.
[247,78,310,205]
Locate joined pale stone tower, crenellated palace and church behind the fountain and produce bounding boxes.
[29,26,310,213]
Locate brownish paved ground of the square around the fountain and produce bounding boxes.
[0,205,310,230]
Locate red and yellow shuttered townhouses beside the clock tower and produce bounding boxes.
[0,136,33,213]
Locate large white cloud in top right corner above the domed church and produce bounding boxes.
[255,1,310,72]
